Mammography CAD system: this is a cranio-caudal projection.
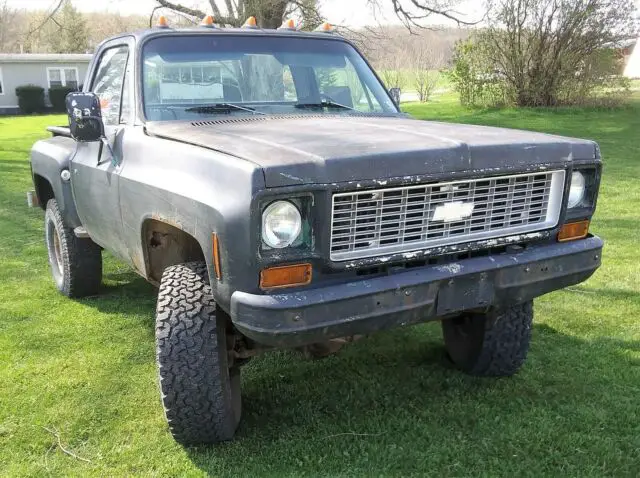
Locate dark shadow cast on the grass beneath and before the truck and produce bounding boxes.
[179,324,640,476]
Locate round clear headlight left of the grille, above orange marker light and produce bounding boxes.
[262,201,302,249]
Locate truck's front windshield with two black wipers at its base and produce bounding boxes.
[143,34,398,121]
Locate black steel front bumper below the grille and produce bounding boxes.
[231,236,603,347]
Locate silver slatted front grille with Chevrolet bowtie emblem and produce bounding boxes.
[331,171,565,261]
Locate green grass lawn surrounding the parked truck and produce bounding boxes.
[0,102,640,477]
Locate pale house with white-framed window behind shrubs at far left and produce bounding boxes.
[0,53,92,114]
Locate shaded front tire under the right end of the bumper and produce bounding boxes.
[442,301,533,377]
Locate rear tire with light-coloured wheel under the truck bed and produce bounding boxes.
[44,199,102,298]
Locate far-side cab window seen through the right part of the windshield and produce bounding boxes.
[316,59,382,112]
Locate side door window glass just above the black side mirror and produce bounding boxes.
[91,46,129,125]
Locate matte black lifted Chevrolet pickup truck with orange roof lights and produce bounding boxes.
[31,16,603,444]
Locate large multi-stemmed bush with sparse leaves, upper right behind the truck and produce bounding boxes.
[458,0,638,106]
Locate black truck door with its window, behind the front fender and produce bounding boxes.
[71,38,133,258]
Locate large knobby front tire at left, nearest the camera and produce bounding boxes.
[156,262,241,446]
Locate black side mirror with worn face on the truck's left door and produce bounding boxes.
[65,91,104,143]
